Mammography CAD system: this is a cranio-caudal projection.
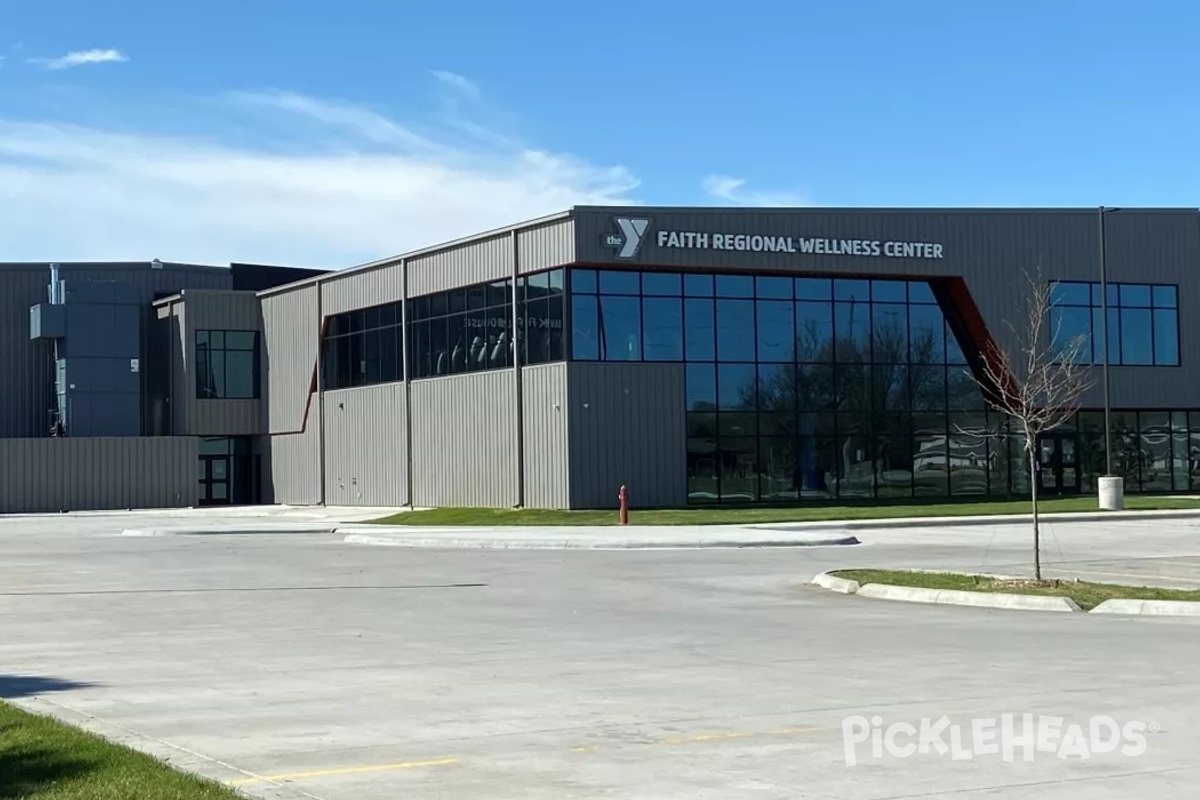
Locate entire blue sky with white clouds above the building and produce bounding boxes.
[0,0,1200,266]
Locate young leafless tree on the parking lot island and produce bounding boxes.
[971,272,1094,582]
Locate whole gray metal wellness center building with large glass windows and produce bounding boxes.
[0,207,1200,511]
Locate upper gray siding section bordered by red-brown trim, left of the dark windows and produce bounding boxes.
[262,284,320,433]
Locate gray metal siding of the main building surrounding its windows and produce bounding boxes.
[263,207,1200,507]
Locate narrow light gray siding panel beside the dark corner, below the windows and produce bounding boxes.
[521,363,571,509]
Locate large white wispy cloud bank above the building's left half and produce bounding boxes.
[0,74,638,267]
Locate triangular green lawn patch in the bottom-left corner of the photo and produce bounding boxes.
[0,702,241,800]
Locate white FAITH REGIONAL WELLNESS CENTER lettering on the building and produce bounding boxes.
[656,230,944,259]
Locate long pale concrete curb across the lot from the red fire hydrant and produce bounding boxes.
[335,528,859,551]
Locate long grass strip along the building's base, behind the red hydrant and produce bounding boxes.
[372,495,1200,525]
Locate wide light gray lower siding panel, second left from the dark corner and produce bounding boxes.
[409,369,517,509]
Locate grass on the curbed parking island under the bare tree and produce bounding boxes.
[833,570,1200,612]
